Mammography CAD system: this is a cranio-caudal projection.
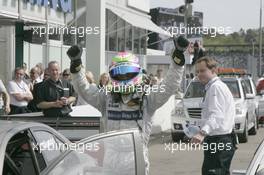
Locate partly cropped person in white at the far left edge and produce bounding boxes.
[0,79,10,115]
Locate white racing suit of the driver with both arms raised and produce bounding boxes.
[72,61,183,175]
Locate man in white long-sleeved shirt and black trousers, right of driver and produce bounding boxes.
[191,57,235,175]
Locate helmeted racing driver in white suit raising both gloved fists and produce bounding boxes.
[67,36,189,175]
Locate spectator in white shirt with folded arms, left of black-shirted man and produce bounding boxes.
[7,67,33,114]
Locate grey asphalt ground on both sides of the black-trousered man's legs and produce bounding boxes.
[149,126,264,175]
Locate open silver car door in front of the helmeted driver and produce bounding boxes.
[46,130,145,175]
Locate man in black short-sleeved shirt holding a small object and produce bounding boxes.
[37,61,76,117]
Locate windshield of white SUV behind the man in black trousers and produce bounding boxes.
[184,81,205,98]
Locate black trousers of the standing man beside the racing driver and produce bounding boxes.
[202,134,236,175]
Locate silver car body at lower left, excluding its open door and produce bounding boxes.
[0,123,71,175]
